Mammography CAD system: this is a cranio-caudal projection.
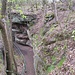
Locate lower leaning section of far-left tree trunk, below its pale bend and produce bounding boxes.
[0,20,12,75]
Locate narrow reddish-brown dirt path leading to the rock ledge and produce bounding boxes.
[17,44,35,75]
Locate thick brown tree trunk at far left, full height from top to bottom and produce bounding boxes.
[0,0,12,75]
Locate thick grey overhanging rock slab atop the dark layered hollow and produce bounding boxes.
[11,13,37,24]
